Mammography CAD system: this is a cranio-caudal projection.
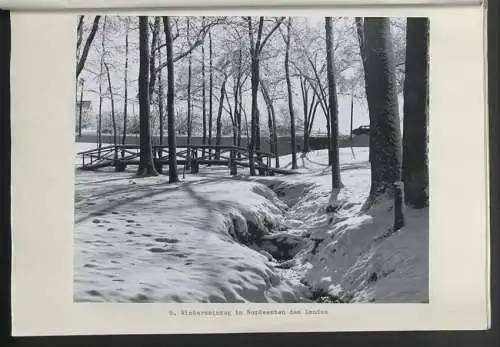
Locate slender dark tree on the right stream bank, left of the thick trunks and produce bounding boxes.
[325,17,342,189]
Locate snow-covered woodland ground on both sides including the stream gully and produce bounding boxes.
[74,143,429,302]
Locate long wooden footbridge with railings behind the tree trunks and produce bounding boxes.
[78,145,293,176]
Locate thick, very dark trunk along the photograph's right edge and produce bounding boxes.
[403,18,429,208]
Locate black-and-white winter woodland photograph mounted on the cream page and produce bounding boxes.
[71,14,431,307]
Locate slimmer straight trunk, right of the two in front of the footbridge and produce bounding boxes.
[163,16,179,183]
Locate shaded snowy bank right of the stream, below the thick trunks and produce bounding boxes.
[260,148,429,302]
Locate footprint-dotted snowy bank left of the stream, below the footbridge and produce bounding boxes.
[74,172,308,302]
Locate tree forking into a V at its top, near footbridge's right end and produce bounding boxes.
[246,17,285,176]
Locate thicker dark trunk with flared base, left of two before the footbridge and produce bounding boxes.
[137,16,158,177]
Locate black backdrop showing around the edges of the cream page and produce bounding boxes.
[0,0,500,347]
